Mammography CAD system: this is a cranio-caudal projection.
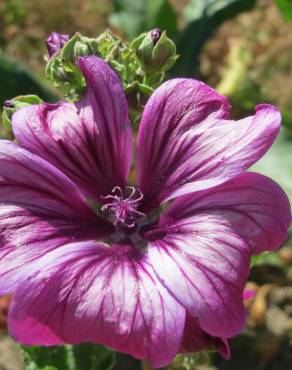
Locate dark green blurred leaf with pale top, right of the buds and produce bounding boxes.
[172,0,256,76]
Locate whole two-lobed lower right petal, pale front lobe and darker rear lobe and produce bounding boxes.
[148,173,291,338]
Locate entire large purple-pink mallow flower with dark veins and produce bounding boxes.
[0,56,291,367]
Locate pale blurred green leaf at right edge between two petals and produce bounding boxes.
[251,129,292,201]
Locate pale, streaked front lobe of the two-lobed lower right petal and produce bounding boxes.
[148,221,250,338]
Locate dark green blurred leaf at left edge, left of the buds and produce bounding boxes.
[0,52,54,105]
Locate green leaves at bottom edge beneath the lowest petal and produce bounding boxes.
[21,343,115,370]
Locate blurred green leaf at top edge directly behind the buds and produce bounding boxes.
[109,0,177,40]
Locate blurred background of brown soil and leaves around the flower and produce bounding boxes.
[0,0,292,370]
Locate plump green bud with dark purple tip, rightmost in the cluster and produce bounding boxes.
[131,28,178,73]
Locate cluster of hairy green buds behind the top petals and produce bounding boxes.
[46,29,177,109]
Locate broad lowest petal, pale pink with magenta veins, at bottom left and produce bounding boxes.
[9,242,185,367]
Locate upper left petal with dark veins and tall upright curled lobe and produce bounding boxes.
[12,56,132,199]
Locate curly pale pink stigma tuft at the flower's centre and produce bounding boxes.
[101,186,145,228]
